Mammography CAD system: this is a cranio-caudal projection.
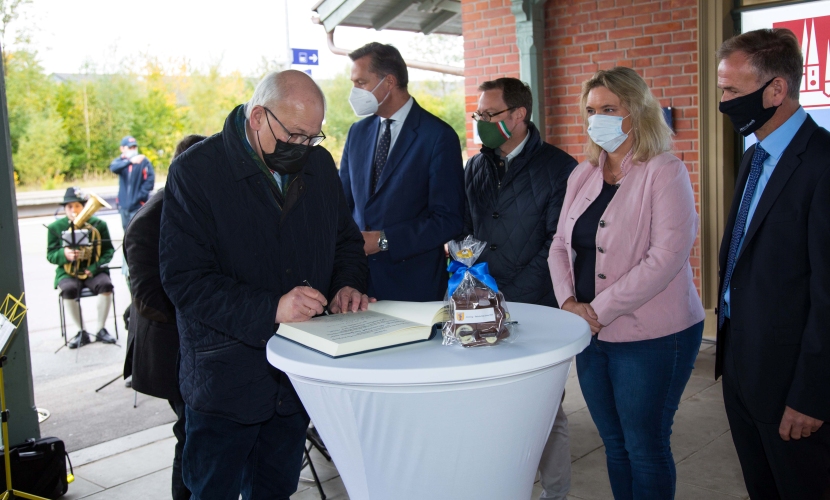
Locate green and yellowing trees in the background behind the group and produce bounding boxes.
[0,29,466,188]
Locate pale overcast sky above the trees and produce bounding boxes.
[7,0,461,80]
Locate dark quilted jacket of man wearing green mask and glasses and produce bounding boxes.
[464,123,576,307]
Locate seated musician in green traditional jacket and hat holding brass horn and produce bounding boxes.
[46,187,115,349]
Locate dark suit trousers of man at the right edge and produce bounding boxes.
[722,321,830,500]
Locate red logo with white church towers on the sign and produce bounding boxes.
[772,16,830,108]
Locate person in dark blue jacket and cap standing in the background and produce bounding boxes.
[110,135,156,230]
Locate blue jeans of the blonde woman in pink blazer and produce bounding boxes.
[576,321,703,500]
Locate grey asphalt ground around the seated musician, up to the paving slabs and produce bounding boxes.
[18,214,176,451]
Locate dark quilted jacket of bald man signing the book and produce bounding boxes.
[159,104,368,424]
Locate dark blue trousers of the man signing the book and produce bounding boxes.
[182,406,309,500]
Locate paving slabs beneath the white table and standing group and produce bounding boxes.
[57,346,748,500]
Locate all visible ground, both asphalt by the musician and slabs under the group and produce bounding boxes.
[19,214,747,500]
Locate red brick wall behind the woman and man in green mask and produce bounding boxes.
[462,0,701,290]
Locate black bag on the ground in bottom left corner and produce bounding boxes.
[0,438,69,498]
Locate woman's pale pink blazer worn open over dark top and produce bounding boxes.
[548,152,705,342]
